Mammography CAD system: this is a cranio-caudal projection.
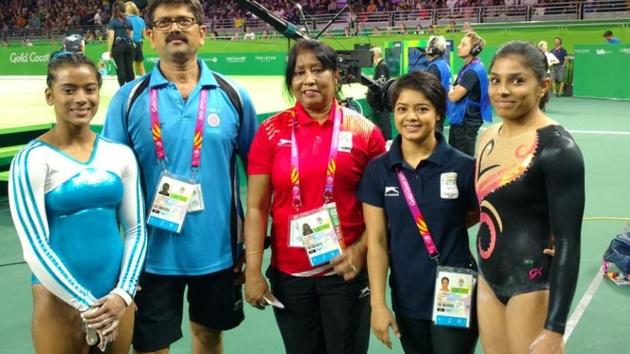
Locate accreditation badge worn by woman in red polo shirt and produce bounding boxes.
[289,203,343,267]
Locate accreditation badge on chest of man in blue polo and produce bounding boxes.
[147,174,195,233]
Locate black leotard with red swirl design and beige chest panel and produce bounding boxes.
[475,125,584,333]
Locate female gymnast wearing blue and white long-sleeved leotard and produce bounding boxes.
[9,53,146,353]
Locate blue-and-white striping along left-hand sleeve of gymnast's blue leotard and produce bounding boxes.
[11,148,91,306]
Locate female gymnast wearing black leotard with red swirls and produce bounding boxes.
[475,42,584,354]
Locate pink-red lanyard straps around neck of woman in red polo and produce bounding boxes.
[291,105,341,210]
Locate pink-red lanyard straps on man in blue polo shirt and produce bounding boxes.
[149,88,208,174]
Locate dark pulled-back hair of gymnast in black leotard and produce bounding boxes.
[490,41,549,109]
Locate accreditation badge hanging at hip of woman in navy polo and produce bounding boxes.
[432,266,477,328]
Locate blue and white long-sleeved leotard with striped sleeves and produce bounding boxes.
[9,136,146,311]
